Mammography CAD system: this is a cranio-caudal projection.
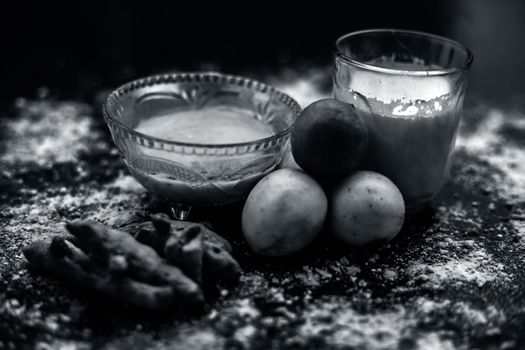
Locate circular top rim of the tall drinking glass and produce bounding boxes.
[335,28,473,76]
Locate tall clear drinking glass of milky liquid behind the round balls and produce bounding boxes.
[333,29,472,211]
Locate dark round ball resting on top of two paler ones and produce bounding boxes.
[291,98,368,177]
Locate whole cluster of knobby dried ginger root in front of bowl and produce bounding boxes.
[23,214,241,310]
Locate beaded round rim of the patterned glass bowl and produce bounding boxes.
[102,72,301,148]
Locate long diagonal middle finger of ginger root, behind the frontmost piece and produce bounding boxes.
[66,222,204,304]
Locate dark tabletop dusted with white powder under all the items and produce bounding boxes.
[0,77,525,350]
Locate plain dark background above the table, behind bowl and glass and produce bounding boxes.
[0,0,525,102]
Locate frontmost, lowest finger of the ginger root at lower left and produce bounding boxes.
[23,237,173,310]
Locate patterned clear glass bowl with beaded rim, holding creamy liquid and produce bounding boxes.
[104,73,301,219]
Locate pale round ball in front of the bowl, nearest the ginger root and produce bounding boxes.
[242,169,328,256]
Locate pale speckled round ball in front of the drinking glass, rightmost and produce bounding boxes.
[328,171,405,246]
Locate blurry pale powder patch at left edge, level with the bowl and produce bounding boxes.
[0,100,99,166]
